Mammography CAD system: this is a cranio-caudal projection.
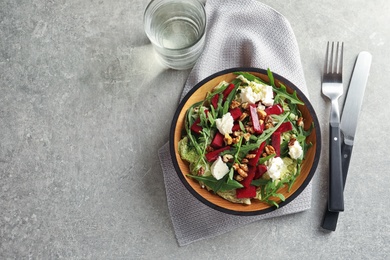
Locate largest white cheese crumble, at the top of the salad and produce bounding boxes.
[237,75,274,106]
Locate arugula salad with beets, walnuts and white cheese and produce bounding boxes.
[178,69,314,207]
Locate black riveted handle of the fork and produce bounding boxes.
[328,123,344,212]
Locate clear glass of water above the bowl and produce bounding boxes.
[144,0,206,70]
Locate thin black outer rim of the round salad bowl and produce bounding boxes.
[169,67,321,216]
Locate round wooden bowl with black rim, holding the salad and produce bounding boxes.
[170,68,321,216]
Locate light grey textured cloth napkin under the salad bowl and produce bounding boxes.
[159,0,311,246]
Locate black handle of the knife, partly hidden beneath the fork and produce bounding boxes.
[322,143,352,231]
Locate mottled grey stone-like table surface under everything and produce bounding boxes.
[0,0,390,259]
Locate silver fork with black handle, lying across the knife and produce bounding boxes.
[322,42,344,212]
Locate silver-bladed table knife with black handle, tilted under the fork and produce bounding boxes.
[322,51,372,231]
